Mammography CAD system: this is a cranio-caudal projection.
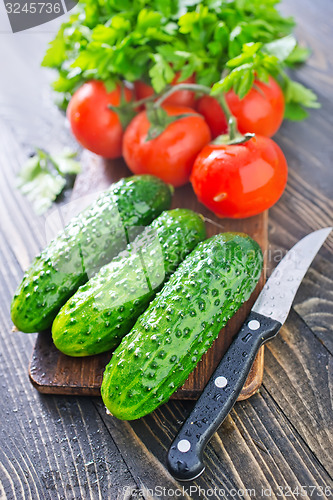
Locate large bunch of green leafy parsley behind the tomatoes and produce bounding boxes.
[42,0,318,119]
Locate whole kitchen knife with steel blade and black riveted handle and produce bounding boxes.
[167,227,332,481]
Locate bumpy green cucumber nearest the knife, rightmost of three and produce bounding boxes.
[101,233,263,420]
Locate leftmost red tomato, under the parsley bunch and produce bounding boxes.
[67,80,132,158]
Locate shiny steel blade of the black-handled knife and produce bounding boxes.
[252,227,332,324]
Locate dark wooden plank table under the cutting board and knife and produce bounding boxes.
[0,0,333,500]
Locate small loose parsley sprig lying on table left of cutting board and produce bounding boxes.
[18,149,81,215]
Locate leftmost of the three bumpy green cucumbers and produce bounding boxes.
[11,175,172,333]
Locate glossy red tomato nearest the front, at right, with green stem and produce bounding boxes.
[190,136,288,218]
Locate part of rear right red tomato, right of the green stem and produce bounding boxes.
[226,77,284,137]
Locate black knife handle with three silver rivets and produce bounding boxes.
[167,311,281,481]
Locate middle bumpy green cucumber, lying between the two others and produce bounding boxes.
[52,209,206,356]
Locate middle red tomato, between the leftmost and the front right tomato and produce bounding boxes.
[123,104,211,187]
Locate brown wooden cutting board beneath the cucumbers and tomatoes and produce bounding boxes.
[29,153,267,399]
